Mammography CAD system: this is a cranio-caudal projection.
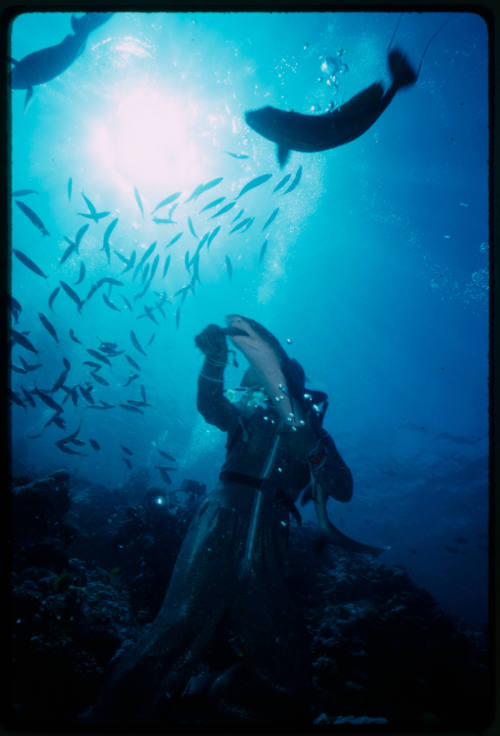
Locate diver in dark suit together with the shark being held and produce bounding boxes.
[94,315,382,724]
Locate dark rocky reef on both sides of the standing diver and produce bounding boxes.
[6,472,489,730]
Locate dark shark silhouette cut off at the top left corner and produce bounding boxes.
[10,13,113,108]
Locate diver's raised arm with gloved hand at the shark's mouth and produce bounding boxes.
[194,324,239,432]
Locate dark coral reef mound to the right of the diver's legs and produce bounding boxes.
[292,532,488,729]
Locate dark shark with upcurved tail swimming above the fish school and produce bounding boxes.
[245,49,418,167]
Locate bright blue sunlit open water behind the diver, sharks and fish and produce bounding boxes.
[11,12,489,625]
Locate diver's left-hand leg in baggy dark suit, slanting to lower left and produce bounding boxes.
[95,503,242,722]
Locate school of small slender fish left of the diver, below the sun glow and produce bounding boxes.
[8,163,302,474]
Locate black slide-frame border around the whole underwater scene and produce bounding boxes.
[0,0,500,736]
